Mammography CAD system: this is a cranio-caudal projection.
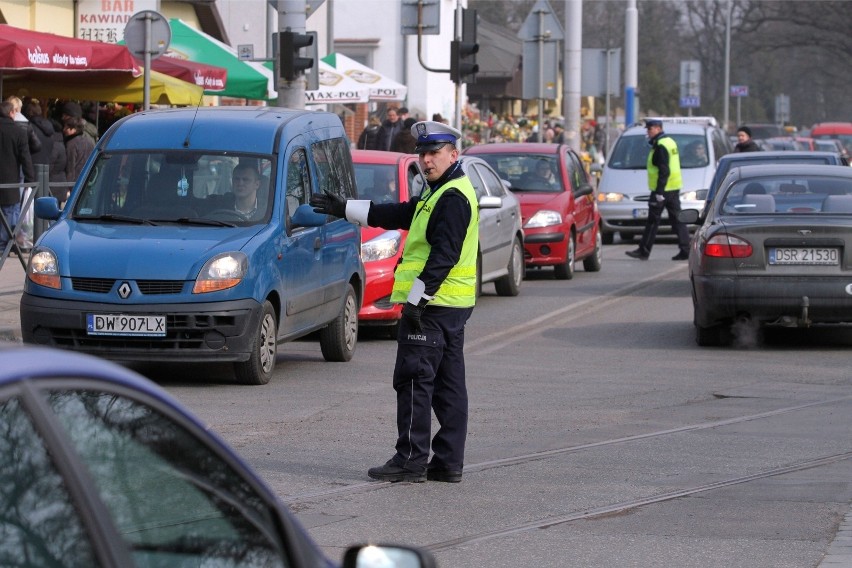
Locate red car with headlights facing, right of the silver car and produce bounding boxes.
[464,143,603,280]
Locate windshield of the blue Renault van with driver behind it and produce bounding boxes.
[72,151,275,226]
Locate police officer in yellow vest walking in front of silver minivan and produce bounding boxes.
[624,119,689,260]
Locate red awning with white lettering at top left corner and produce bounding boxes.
[0,24,142,76]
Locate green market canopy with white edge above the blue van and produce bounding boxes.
[165,18,278,100]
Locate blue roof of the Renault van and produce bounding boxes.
[98,107,345,154]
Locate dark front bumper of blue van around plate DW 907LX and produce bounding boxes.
[21,293,261,363]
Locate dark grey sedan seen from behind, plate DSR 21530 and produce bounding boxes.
[680,163,852,345]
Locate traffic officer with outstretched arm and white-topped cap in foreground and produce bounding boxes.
[311,121,479,483]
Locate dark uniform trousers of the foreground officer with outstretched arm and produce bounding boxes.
[393,306,473,470]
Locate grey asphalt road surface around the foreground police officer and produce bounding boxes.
[133,245,852,568]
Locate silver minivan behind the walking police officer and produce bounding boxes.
[596,116,733,244]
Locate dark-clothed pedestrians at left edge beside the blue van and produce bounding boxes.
[0,96,97,253]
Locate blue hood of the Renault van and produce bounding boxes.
[38,221,263,280]
